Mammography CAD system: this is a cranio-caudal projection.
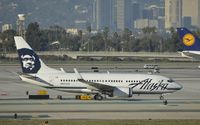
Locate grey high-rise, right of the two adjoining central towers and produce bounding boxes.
[116,0,133,30]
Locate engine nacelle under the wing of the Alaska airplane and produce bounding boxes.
[112,87,133,97]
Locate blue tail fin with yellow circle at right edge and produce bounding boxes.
[177,28,200,51]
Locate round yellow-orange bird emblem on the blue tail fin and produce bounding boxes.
[183,33,195,46]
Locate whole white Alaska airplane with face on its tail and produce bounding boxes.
[14,36,182,103]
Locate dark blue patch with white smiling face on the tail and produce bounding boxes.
[18,48,41,73]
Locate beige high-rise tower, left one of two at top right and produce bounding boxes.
[165,0,182,29]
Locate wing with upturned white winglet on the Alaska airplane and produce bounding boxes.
[74,68,115,91]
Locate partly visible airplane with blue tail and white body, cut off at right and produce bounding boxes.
[177,28,200,60]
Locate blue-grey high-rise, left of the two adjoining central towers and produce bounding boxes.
[93,0,114,30]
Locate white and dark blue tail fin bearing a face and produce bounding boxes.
[14,36,60,74]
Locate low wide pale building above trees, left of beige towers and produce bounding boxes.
[134,19,158,29]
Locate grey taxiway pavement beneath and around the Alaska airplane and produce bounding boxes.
[0,63,200,119]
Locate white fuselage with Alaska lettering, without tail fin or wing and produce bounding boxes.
[21,72,182,94]
